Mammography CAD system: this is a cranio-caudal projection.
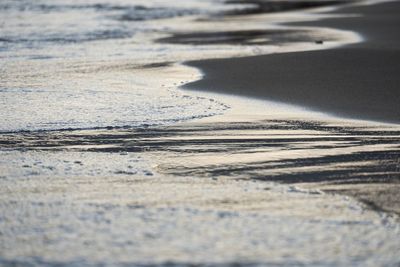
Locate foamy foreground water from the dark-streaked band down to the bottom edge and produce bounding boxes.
[0,120,400,266]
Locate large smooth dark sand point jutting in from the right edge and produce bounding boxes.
[185,2,400,123]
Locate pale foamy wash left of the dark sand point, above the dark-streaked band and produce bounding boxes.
[0,0,357,132]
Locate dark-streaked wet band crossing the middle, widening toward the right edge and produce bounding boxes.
[0,117,400,215]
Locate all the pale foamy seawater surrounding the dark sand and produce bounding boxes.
[0,0,400,266]
